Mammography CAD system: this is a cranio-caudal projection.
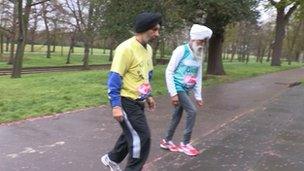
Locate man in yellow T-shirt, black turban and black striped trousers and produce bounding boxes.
[101,12,161,171]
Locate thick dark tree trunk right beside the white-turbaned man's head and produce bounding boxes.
[207,32,225,75]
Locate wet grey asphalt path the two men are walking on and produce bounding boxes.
[0,68,304,171]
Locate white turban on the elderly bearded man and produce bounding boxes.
[190,24,212,40]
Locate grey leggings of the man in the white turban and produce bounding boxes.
[165,92,197,144]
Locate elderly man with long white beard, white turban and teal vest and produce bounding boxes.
[160,24,212,156]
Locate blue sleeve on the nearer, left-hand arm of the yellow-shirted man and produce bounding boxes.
[108,72,122,107]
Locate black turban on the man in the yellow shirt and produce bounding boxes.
[134,12,161,33]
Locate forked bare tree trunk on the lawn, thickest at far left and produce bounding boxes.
[12,0,32,78]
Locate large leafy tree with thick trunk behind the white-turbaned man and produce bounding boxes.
[179,0,258,75]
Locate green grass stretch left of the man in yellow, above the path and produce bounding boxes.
[0,71,107,123]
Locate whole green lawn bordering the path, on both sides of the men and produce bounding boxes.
[0,62,303,123]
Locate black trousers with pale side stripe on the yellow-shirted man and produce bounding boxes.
[108,97,151,171]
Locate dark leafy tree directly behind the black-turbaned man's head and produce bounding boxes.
[100,0,184,63]
